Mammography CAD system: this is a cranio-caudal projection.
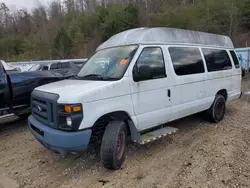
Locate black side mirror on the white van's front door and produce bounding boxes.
[134,65,153,82]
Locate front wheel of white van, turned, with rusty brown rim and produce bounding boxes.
[100,121,127,170]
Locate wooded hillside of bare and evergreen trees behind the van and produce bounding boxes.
[0,0,250,61]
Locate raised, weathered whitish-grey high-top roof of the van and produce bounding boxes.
[97,27,234,51]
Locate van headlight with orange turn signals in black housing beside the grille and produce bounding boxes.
[58,104,83,131]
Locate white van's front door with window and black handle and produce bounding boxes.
[131,46,171,130]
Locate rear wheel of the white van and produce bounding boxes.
[207,94,226,123]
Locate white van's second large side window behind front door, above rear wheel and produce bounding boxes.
[202,48,232,72]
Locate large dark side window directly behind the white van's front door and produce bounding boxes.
[168,47,205,76]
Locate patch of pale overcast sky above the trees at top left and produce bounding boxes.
[0,0,50,11]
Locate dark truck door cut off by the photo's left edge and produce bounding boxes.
[0,62,10,111]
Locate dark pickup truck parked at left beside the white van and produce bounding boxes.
[0,60,70,119]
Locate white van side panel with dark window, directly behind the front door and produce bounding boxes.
[168,46,207,120]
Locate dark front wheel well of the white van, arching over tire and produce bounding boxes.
[91,111,132,145]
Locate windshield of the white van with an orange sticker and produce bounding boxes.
[77,45,138,80]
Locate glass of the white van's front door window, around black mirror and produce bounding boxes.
[133,47,166,80]
